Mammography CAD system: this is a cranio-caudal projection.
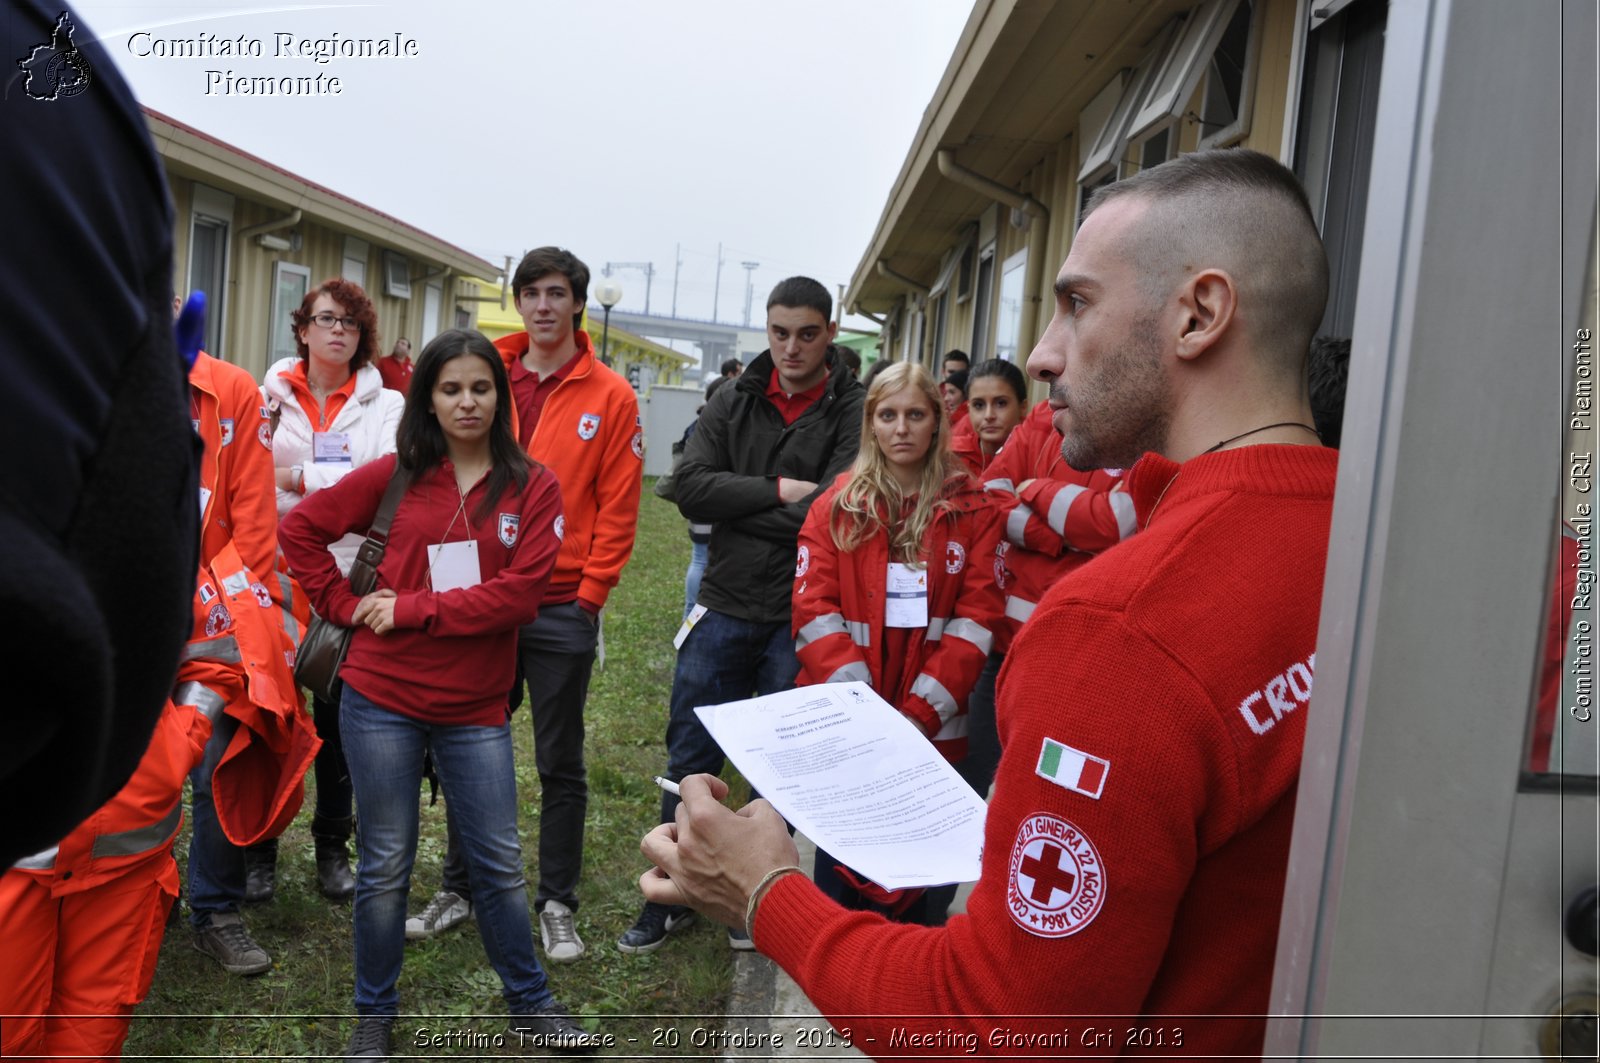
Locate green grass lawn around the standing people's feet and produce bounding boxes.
[125,482,748,1058]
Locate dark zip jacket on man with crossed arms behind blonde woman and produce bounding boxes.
[677,347,866,623]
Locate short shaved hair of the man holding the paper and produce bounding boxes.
[1083,147,1328,373]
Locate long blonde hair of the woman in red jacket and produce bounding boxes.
[829,362,971,564]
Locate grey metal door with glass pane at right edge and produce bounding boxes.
[1266,0,1600,1060]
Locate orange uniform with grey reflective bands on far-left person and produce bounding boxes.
[0,354,317,1058]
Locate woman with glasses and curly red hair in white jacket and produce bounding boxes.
[254,279,405,903]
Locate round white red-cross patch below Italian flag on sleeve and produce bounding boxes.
[1006,812,1106,938]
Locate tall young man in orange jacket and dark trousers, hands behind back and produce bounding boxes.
[406,247,645,964]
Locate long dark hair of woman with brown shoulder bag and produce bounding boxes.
[395,328,544,519]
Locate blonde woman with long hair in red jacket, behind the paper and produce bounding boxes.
[794,363,1003,922]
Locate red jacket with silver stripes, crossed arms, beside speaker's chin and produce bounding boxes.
[984,402,1136,653]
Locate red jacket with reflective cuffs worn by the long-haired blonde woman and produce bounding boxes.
[792,472,1002,760]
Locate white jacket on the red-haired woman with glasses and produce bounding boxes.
[261,357,405,575]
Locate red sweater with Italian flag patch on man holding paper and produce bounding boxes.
[755,445,1338,1057]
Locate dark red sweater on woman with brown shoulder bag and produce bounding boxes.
[278,455,562,727]
